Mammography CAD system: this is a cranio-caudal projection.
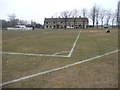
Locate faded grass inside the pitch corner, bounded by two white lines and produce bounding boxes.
[3,30,78,54]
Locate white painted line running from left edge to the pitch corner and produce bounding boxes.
[0,52,68,57]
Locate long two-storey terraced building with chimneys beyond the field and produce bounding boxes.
[44,17,88,29]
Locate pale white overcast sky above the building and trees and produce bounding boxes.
[0,0,119,24]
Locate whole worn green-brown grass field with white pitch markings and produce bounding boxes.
[2,30,118,88]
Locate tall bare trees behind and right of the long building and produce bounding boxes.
[59,4,120,28]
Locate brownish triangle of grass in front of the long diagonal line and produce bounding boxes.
[5,53,118,88]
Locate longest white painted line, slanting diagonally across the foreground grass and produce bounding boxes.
[0,50,120,86]
